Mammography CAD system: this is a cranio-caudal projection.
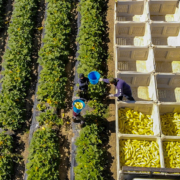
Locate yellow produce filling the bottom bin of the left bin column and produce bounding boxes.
[120,139,160,168]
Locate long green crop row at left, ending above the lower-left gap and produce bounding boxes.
[0,0,39,130]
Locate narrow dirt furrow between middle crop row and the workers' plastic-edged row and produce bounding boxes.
[59,3,77,180]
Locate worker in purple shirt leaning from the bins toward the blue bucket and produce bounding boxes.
[99,78,135,101]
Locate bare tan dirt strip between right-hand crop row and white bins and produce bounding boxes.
[107,0,117,180]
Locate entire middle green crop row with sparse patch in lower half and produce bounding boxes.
[26,0,72,180]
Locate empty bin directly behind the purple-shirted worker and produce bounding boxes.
[117,73,157,101]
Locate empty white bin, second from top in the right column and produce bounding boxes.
[151,22,180,46]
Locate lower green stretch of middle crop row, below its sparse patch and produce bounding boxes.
[27,128,60,180]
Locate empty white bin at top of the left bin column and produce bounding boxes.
[115,0,149,22]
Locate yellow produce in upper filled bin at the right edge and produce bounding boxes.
[161,113,180,136]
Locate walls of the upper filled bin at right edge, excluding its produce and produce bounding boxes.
[158,103,180,139]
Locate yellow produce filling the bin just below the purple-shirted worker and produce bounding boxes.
[118,108,154,135]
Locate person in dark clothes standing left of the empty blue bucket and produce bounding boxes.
[79,74,89,99]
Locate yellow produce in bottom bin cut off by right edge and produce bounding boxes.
[163,141,180,168]
